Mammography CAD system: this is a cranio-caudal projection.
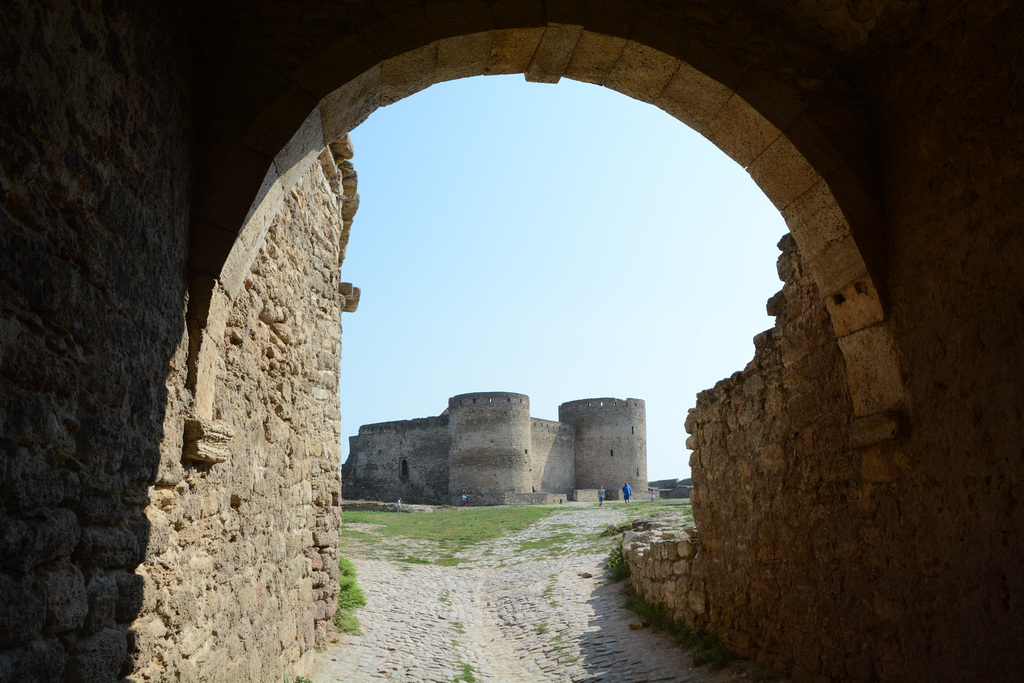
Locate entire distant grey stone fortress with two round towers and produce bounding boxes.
[342,392,647,505]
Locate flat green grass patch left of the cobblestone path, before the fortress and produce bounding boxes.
[341,505,558,566]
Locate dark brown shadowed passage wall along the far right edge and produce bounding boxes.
[857,3,1024,680]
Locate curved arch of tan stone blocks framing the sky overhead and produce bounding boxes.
[189,12,905,432]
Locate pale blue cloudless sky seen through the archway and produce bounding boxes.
[341,76,786,479]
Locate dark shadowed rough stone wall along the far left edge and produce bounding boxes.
[0,0,191,682]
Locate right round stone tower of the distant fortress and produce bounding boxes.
[558,398,647,496]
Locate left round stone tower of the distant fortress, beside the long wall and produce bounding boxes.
[447,391,532,502]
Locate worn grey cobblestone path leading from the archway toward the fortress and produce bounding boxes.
[313,504,765,683]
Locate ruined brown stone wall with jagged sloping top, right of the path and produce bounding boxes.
[672,234,864,680]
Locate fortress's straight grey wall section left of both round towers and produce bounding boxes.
[342,416,452,505]
